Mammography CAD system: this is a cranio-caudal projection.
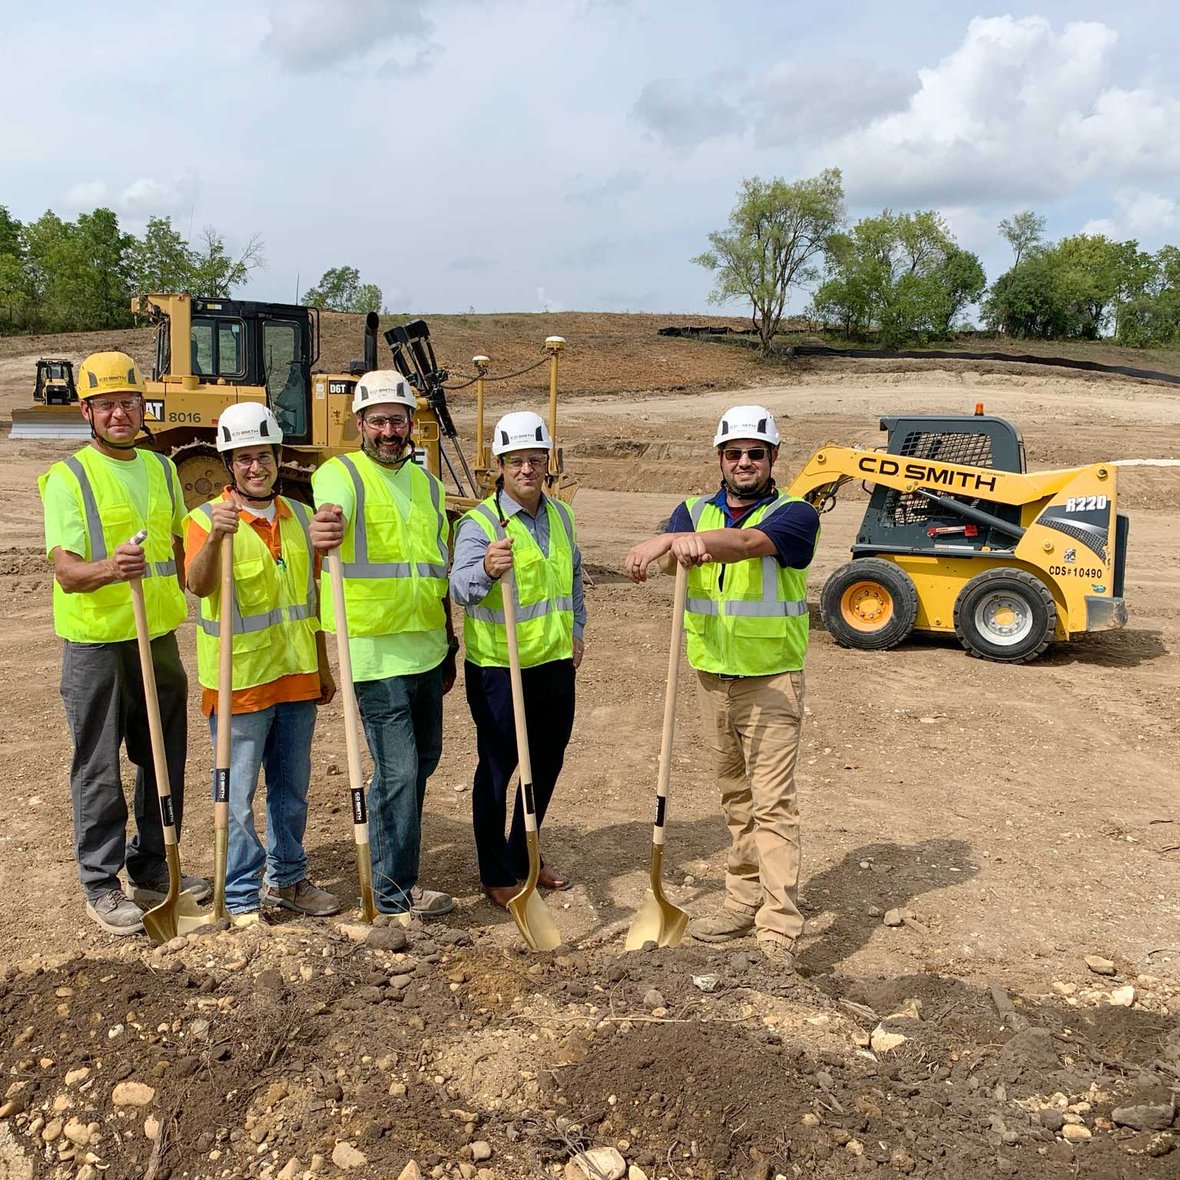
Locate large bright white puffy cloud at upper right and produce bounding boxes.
[813,17,1180,204]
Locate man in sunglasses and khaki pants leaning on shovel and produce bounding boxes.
[624,406,819,970]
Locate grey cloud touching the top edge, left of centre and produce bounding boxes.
[262,0,434,74]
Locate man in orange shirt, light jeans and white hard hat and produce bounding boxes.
[184,401,340,925]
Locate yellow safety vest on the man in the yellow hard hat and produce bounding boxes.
[38,447,189,643]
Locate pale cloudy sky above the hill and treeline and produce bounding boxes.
[0,0,1180,314]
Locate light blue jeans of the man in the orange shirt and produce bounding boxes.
[209,701,315,913]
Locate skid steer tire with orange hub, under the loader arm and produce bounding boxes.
[819,557,918,651]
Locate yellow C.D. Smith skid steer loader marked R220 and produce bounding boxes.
[787,405,1129,663]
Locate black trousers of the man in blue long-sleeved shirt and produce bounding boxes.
[465,660,575,886]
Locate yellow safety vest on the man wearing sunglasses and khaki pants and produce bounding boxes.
[684,494,808,676]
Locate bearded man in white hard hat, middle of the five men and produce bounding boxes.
[312,369,459,918]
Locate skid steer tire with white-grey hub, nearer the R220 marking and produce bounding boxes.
[955,566,1057,663]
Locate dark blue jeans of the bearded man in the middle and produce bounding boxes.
[354,664,443,913]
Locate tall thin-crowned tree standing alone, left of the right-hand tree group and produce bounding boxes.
[693,168,844,353]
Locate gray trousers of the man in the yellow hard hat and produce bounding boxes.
[61,632,189,900]
